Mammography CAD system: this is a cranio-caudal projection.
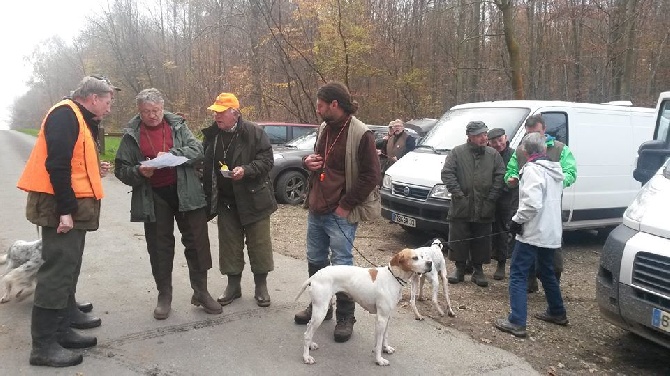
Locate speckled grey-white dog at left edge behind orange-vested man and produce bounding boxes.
[0,239,44,303]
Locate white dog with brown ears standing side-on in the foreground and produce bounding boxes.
[296,249,432,366]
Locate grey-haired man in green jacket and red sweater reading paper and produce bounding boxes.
[114,88,222,320]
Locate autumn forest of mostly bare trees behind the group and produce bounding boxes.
[6,0,670,131]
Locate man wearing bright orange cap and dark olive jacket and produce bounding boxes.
[202,93,277,307]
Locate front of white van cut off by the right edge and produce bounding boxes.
[596,156,670,348]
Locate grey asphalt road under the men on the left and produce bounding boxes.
[0,131,537,376]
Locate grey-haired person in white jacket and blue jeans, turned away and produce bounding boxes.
[494,133,568,337]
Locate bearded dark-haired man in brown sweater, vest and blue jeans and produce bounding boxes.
[294,82,381,342]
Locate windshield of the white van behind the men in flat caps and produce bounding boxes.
[421,107,530,150]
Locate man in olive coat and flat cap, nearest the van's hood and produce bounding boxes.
[442,121,505,287]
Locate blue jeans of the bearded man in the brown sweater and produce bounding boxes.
[307,213,358,266]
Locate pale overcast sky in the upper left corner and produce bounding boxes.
[0,0,107,129]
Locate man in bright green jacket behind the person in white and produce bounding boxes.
[505,115,577,292]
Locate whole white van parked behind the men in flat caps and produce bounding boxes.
[381,100,655,234]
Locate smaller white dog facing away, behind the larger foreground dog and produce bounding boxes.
[409,238,456,320]
